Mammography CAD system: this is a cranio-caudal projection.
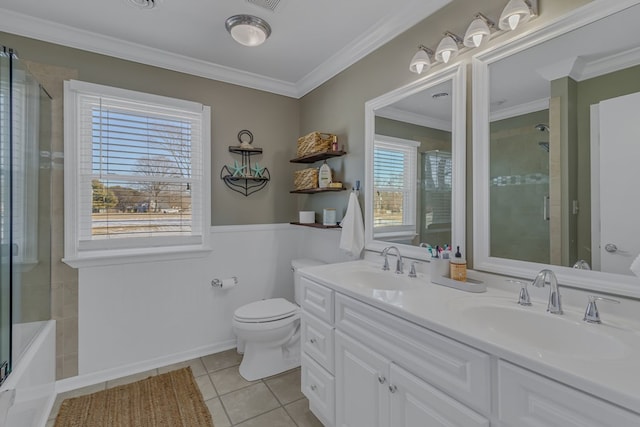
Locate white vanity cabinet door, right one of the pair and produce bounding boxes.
[389,363,489,427]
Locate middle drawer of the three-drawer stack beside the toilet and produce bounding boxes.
[302,310,334,374]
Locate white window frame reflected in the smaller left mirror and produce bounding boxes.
[372,134,420,241]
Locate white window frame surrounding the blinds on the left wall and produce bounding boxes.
[62,80,211,268]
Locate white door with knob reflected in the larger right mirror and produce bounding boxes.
[592,93,640,275]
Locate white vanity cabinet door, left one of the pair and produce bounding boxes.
[335,331,390,427]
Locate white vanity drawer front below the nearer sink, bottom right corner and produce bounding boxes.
[498,361,640,427]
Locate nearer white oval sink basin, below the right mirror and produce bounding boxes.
[452,301,627,360]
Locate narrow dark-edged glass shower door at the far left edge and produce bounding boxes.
[0,46,11,382]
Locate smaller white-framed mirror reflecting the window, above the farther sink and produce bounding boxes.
[364,61,466,259]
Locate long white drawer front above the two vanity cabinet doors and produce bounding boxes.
[335,294,491,414]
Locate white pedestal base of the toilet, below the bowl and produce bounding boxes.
[239,342,300,381]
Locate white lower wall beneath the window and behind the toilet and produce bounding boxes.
[78,224,356,382]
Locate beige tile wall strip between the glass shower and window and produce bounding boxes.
[24,61,78,379]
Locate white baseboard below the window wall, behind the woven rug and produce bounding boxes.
[55,339,236,394]
